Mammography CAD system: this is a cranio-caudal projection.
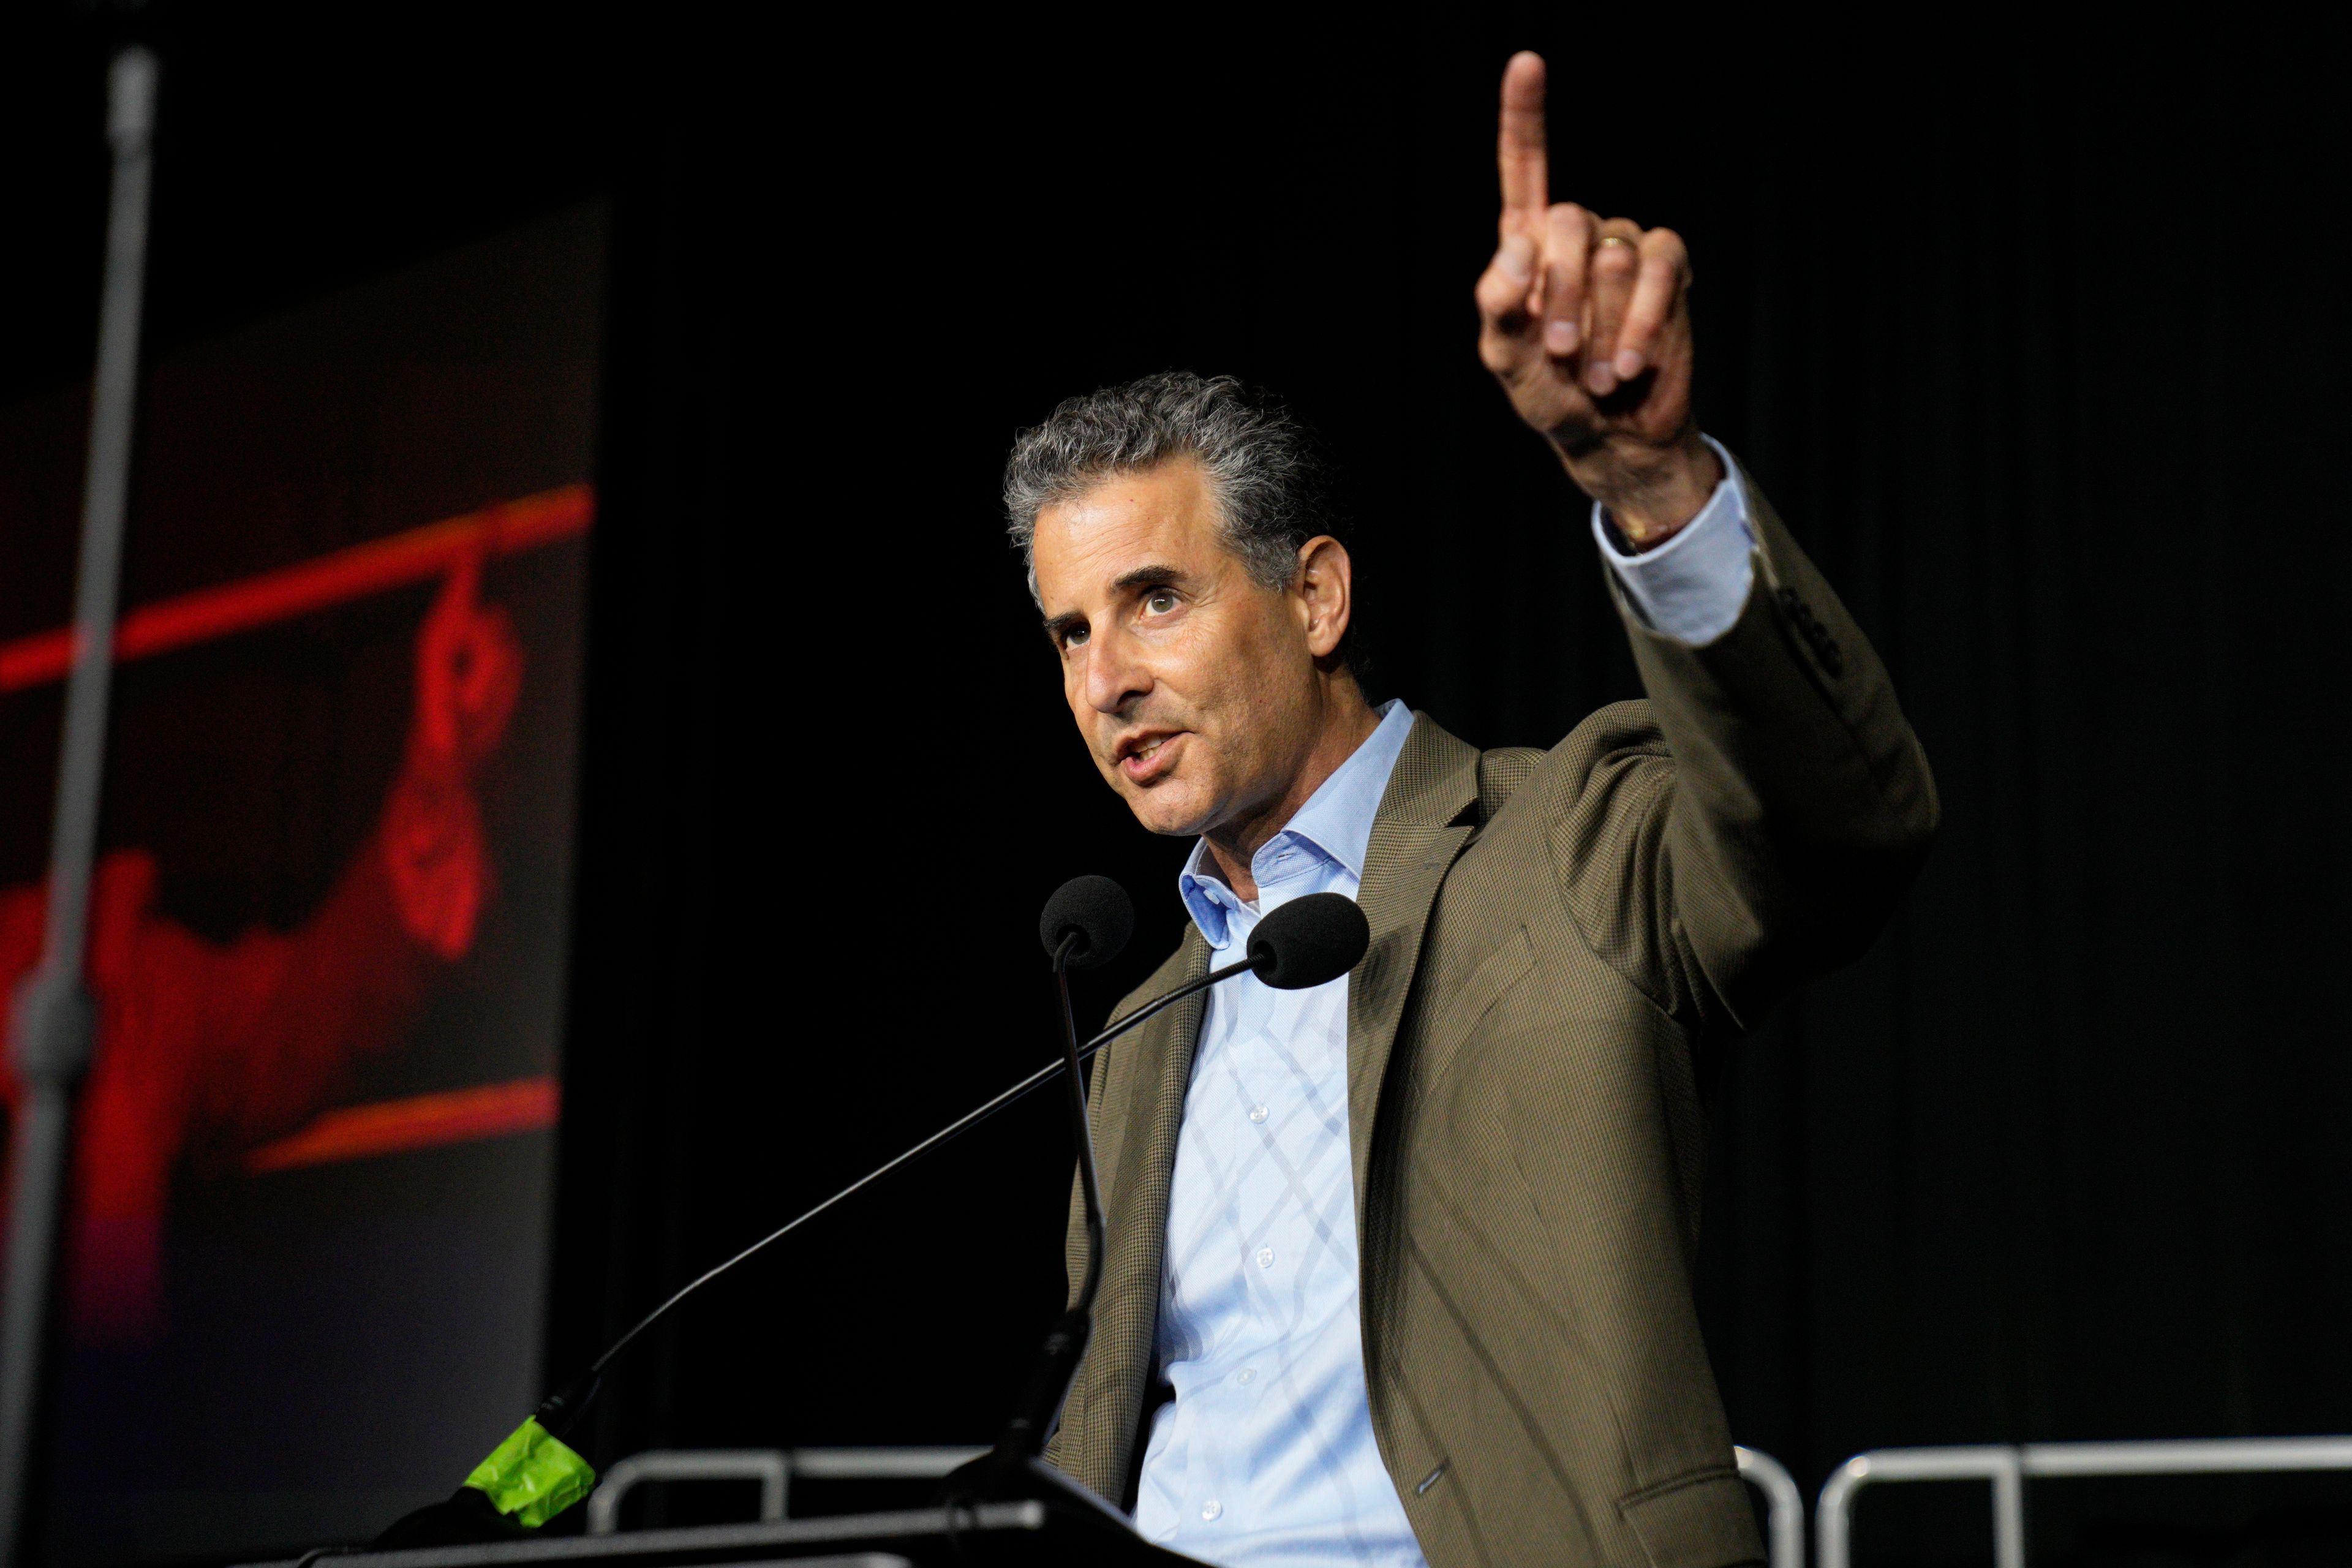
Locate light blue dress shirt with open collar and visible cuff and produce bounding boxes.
[1136,447,1755,1568]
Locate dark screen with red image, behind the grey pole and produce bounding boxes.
[0,209,605,1563]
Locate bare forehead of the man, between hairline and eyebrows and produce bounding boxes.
[1030,458,1230,614]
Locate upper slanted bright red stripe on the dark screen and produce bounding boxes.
[0,484,595,693]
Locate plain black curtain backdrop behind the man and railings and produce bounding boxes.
[0,5,2352,1563]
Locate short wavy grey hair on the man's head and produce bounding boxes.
[1005,371,1331,604]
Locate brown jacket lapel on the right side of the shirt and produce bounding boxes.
[1354,712,1477,1237]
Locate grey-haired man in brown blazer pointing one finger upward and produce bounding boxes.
[1007,54,1936,1568]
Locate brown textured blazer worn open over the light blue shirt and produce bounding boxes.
[1047,491,1936,1568]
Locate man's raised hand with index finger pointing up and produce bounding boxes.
[1477,51,1722,545]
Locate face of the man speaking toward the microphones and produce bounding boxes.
[1033,458,1317,835]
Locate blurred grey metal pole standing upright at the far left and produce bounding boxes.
[0,45,155,1568]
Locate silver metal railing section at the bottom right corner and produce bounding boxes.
[1814,1436,2352,1568]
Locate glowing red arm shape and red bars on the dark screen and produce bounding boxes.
[0,486,590,1340]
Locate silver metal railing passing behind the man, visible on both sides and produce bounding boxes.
[588,1446,1804,1568]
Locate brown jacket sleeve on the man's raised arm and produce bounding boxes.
[1543,477,1938,1030]
